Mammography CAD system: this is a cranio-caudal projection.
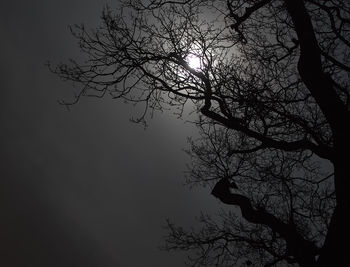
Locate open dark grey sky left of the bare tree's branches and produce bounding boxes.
[0,0,222,267]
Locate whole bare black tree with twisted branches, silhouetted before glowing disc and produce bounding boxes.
[52,0,350,266]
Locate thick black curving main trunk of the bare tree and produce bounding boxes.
[285,0,350,267]
